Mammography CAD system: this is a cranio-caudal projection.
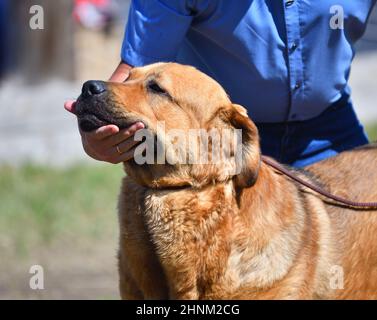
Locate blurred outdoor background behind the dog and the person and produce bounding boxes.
[0,0,377,299]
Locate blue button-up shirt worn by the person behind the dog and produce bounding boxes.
[122,0,376,123]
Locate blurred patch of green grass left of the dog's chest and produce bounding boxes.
[0,165,124,255]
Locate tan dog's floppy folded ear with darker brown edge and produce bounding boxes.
[219,104,261,188]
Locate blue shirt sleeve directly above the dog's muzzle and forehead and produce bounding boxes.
[121,0,197,67]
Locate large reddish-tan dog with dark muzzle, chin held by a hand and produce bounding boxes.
[77,64,377,299]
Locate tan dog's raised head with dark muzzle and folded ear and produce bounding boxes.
[76,63,260,188]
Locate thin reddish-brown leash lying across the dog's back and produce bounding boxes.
[262,156,377,210]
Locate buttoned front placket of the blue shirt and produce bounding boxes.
[283,0,304,121]
